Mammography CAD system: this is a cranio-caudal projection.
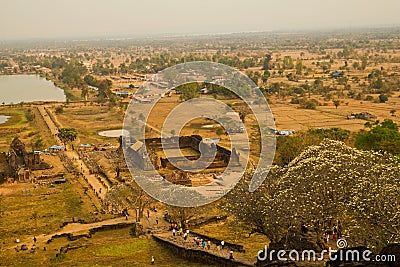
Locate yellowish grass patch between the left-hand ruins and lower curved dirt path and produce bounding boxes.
[0,181,93,244]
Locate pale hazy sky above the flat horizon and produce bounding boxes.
[0,0,400,40]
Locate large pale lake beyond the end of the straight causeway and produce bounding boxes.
[0,75,65,104]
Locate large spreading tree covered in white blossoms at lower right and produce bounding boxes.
[225,140,400,249]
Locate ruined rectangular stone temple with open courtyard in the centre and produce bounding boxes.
[123,135,240,186]
